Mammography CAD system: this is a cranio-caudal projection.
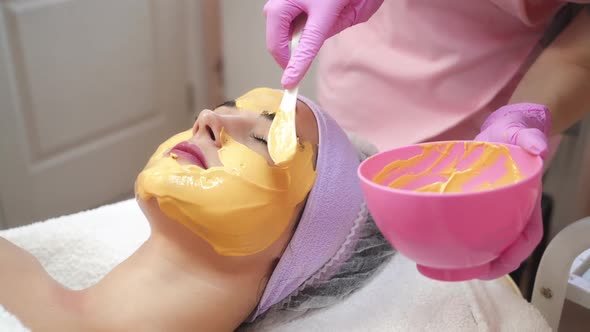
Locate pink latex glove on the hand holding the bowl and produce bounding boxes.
[475,103,551,280]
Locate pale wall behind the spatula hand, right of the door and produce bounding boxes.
[221,0,316,99]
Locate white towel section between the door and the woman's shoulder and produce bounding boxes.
[0,200,149,289]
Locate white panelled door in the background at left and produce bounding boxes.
[0,0,190,228]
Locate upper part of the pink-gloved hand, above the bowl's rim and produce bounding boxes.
[475,103,551,158]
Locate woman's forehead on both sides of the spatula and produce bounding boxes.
[236,88,319,145]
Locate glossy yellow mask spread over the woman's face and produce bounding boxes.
[136,89,316,256]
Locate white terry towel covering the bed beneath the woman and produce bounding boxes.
[0,200,550,332]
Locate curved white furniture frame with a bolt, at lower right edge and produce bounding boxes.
[531,217,590,331]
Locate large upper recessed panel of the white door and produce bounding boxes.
[7,0,155,156]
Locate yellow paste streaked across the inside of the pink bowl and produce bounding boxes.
[373,142,523,193]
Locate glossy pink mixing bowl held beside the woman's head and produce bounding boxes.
[358,141,543,281]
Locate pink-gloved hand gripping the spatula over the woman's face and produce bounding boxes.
[264,0,383,89]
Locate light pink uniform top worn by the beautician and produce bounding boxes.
[318,0,590,150]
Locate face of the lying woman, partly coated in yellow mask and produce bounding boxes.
[136,89,318,256]
